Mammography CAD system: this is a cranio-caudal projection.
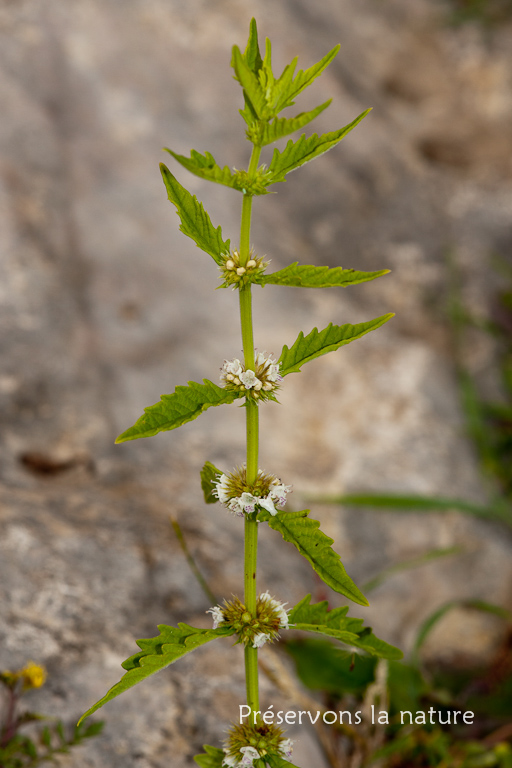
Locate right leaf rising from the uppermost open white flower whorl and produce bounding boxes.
[278,313,394,376]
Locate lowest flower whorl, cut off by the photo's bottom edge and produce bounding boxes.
[222,723,293,768]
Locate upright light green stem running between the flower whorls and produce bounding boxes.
[239,147,261,711]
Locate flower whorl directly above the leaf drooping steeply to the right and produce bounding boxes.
[213,467,292,517]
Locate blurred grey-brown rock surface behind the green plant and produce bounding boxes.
[0,0,512,768]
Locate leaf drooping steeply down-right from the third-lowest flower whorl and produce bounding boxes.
[256,509,369,605]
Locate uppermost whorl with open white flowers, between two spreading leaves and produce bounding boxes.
[220,352,283,400]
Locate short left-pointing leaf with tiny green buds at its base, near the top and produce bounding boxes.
[164,147,272,195]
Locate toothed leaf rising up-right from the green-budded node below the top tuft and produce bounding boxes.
[269,109,371,183]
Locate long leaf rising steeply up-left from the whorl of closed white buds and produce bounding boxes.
[160,163,230,266]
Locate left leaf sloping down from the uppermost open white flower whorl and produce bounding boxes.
[116,379,240,443]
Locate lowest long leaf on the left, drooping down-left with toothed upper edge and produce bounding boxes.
[78,624,233,725]
